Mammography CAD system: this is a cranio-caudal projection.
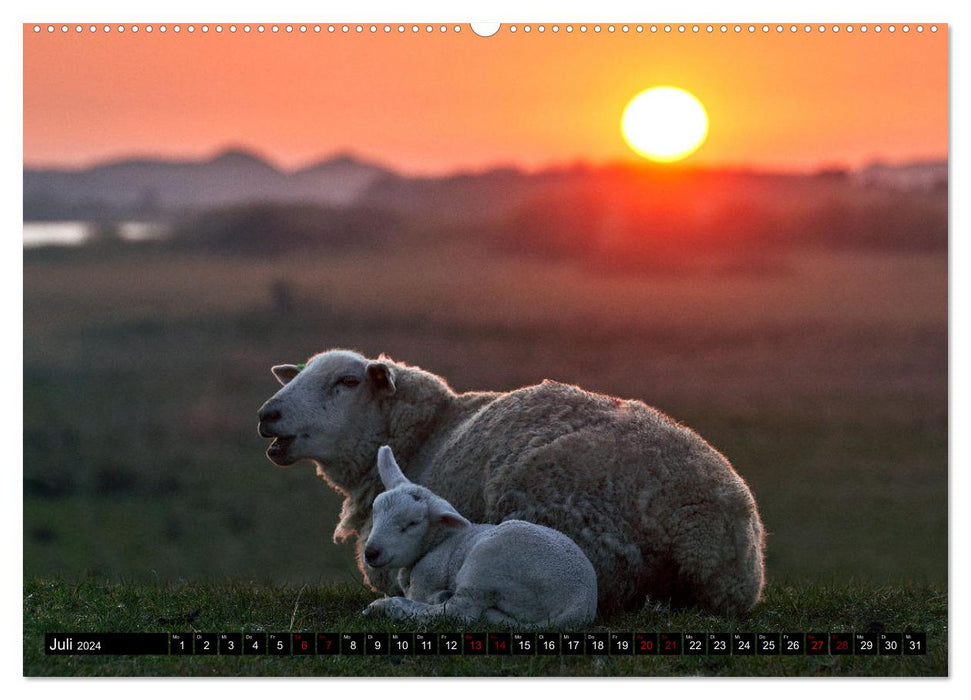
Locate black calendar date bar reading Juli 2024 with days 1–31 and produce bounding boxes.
[44,632,927,662]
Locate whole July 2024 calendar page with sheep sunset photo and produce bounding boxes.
[22,16,949,677]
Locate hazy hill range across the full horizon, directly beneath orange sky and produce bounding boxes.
[24,149,947,221]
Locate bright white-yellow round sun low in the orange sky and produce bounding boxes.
[620,86,708,163]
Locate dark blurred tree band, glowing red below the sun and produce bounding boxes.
[34,167,948,269]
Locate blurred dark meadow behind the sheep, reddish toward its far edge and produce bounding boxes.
[24,237,947,585]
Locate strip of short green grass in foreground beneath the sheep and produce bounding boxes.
[24,577,948,676]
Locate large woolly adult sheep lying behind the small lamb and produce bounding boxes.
[259,350,764,614]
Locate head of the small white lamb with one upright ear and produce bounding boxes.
[364,445,470,569]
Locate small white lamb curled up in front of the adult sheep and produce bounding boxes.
[364,445,597,629]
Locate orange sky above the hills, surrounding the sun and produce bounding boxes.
[24,24,948,173]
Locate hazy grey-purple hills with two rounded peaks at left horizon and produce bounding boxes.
[24,149,392,220]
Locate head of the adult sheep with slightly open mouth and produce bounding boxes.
[258,350,395,467]
